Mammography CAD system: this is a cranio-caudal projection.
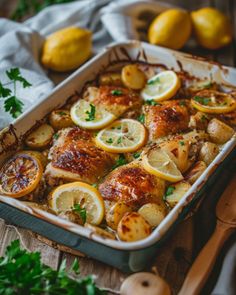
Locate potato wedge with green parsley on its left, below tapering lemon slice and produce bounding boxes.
[164,180,191,208]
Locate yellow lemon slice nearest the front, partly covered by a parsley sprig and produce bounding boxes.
[49,182,105,225]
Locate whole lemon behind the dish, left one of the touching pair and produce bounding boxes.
[148,9,191,49]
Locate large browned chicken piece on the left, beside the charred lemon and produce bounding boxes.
[45,127,114,186]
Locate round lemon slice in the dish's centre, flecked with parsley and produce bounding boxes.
[96,119,147,153]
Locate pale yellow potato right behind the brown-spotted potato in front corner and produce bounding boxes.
[138,203,166,227]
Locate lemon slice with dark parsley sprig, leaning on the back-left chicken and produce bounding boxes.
[70,99,116,129]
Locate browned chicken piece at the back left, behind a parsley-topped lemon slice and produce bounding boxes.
[84,86,142,117]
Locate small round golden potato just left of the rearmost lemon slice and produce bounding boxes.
[121,64,147,90]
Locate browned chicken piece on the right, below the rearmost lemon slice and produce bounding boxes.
[144,100,190,140]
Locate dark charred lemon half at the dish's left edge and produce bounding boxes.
[0,152,43,198]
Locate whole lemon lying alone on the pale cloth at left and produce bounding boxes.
[42,27,92,72]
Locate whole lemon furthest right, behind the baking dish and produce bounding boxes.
[191,7,233,49]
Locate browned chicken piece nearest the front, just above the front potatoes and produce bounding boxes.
[99,161,165,209]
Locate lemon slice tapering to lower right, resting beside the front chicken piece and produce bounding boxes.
[142,147,183,182]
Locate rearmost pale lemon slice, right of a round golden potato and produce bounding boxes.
[141,71,181,101]
